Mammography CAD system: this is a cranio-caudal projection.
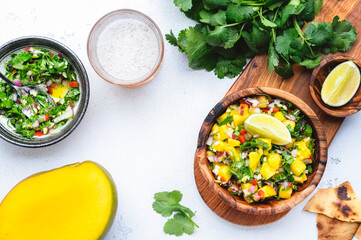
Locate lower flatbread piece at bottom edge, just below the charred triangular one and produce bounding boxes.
[317,214,360,240]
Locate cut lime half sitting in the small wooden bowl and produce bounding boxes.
[321,61,360,107]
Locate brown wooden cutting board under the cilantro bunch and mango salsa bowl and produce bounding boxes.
[194,0,361,226]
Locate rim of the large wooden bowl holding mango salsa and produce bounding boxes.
[194,87,328,215]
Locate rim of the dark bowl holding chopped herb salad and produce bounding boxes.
[0,35,90,148]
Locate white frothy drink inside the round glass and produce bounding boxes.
[96,18,159,80]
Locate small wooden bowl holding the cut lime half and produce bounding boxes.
[309,56,361,117]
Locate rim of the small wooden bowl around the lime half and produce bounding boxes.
[309,54,361,117]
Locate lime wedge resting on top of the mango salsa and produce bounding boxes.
[244,114,292,145]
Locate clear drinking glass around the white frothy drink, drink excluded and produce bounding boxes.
[87,9,164,88]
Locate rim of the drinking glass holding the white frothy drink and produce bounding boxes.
[87,8,164,87]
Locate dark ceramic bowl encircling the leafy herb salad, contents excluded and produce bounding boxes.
[0,36,89,148]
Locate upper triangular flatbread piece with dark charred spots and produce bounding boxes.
[303,182,361,222]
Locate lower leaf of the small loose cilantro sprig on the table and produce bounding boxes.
[163,213,194,237]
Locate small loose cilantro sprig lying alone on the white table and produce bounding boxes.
[152,190,198,236]
